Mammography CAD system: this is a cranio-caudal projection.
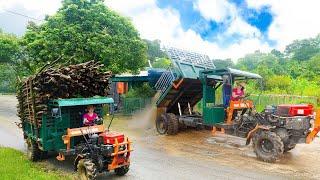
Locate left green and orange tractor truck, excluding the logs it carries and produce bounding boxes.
[22,97,132,179]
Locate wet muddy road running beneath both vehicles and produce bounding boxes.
[0,96,320,179]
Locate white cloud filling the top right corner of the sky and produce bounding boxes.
[247,0,320,50]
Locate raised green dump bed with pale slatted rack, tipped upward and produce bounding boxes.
[155,48,215,114]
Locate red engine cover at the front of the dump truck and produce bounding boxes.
[277,104,313,117]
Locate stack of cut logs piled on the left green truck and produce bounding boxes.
[17,61,111,127]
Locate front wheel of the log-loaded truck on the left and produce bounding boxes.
[77,159,97,180]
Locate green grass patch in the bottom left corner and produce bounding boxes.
[0,147,72,180]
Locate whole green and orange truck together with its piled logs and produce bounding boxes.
[17,61,132,179]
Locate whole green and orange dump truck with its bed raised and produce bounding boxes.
[156,48,320,162]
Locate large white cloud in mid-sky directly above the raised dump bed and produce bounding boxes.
[105,0,270,59]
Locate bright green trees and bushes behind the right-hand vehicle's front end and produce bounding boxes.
[221,35,320,97]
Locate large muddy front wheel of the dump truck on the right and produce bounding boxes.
[252,131,284,163]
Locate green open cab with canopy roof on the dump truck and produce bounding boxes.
[200,68,262,130]
